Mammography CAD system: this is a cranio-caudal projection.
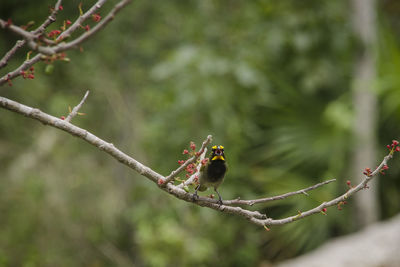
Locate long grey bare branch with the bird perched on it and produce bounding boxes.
[0,92,394,227]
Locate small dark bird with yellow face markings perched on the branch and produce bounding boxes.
[193,145,228,205]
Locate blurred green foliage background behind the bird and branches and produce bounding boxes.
[0,0,400,266]
